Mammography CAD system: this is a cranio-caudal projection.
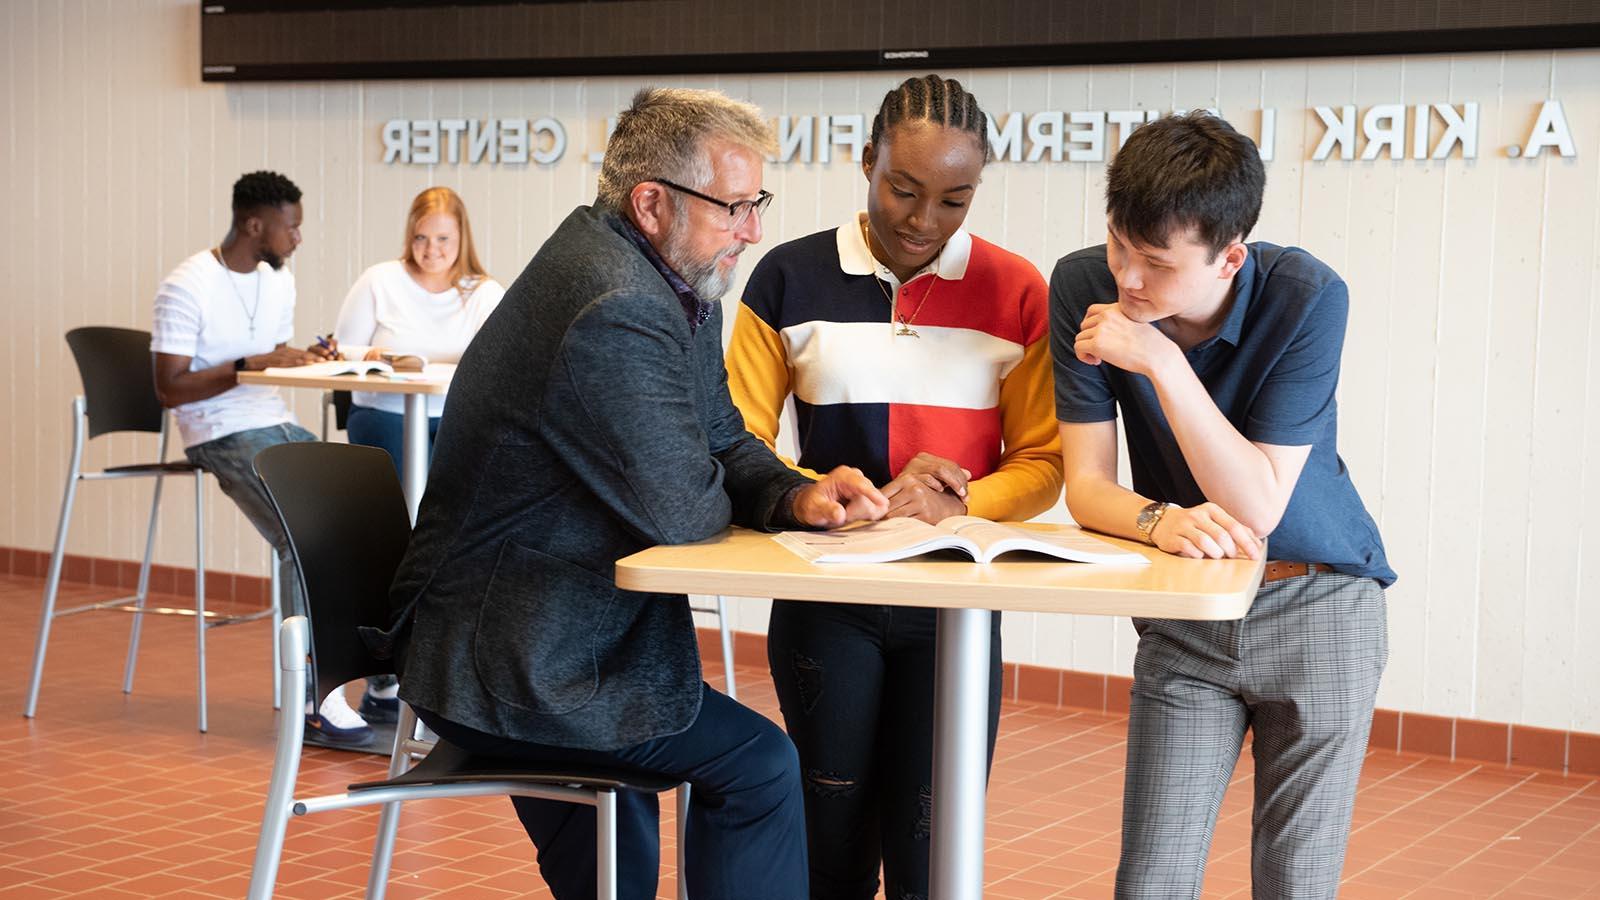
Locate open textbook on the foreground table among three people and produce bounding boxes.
[773,516,1149,565]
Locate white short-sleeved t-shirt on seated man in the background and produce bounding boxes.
[150,250,294,447]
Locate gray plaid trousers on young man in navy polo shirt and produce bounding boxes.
[1117,572,1389,898]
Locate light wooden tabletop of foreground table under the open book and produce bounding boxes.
[616,524,1264,620]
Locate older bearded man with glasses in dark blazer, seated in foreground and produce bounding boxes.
[368,90,888,900]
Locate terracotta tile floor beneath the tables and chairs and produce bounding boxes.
[0,577,1600,900]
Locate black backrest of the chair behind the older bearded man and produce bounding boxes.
[256,442,411,701]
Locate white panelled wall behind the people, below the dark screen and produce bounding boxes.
[0,0,1600,732]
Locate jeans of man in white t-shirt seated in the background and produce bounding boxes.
[184,423,317,614]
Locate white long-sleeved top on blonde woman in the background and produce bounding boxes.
[333,259,506,416]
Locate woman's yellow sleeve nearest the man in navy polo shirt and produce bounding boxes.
[966,336,1062,522]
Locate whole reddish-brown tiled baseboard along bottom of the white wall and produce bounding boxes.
[9,548,1600,775]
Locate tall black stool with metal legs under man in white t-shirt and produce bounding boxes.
[22,327,282,732]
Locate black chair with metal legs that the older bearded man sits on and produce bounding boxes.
[250,444,683,900]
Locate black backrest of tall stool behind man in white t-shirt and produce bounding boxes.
[67,325,166,437]
